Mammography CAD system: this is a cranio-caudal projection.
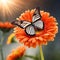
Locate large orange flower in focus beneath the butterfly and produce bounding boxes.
[14,10,58,47]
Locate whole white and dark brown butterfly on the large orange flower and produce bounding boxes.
[12,8,44,36]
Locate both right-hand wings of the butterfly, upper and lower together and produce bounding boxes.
[32,7,44,30]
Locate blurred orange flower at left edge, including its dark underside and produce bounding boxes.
[0,21,14,32]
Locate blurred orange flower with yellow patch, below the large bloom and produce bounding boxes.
[6,46,25,60]
